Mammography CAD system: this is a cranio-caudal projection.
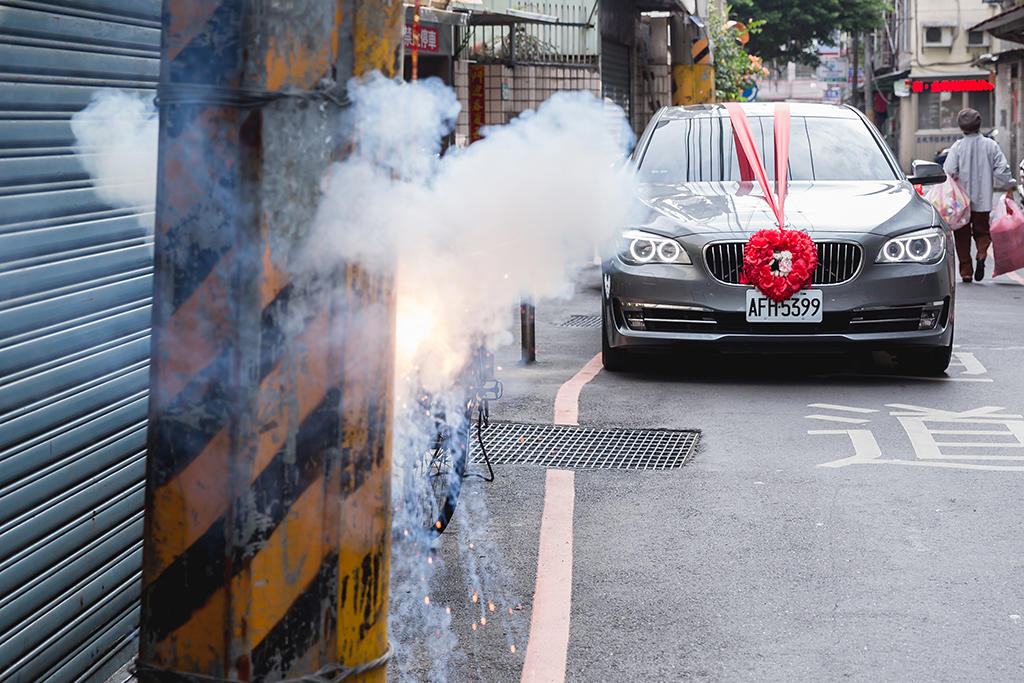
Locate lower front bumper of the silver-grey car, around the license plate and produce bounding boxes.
[603,233,954,352]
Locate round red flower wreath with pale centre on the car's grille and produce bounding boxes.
[739,229,818,301]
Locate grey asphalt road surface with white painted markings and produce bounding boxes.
[391,269,1024,681]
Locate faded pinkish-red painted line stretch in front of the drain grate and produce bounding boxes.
[520,471,573,683]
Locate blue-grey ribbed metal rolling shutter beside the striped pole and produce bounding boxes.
[0,0,161,683]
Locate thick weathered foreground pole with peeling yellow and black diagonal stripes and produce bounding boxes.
[138,0,403,682]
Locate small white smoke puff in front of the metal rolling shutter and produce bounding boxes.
[71,91,159,208]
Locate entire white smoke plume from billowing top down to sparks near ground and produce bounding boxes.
[310,78,634,681]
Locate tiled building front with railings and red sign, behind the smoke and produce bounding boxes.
[404,0,709,146]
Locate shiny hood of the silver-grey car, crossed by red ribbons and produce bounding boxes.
[634,180,939,238]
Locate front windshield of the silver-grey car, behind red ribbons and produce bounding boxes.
[639,116,896,184]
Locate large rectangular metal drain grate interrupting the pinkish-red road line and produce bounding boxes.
[470,422,700,470]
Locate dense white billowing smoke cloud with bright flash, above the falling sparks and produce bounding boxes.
[313,78,633,389]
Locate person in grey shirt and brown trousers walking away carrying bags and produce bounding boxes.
[942,109,1013,283]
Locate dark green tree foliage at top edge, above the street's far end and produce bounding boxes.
[732,0,892,66]
